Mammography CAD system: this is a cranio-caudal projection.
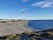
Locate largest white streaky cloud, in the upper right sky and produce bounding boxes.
[31,0,53,8]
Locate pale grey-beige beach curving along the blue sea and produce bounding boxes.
[0,20,31,36]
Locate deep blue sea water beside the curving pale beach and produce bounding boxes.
[28,20,53,30]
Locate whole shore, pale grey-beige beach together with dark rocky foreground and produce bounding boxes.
[0,20,53,40]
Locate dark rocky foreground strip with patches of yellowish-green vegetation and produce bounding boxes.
[0,29,53,40]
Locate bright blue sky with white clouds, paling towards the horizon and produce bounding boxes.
[0,0,53,20]
